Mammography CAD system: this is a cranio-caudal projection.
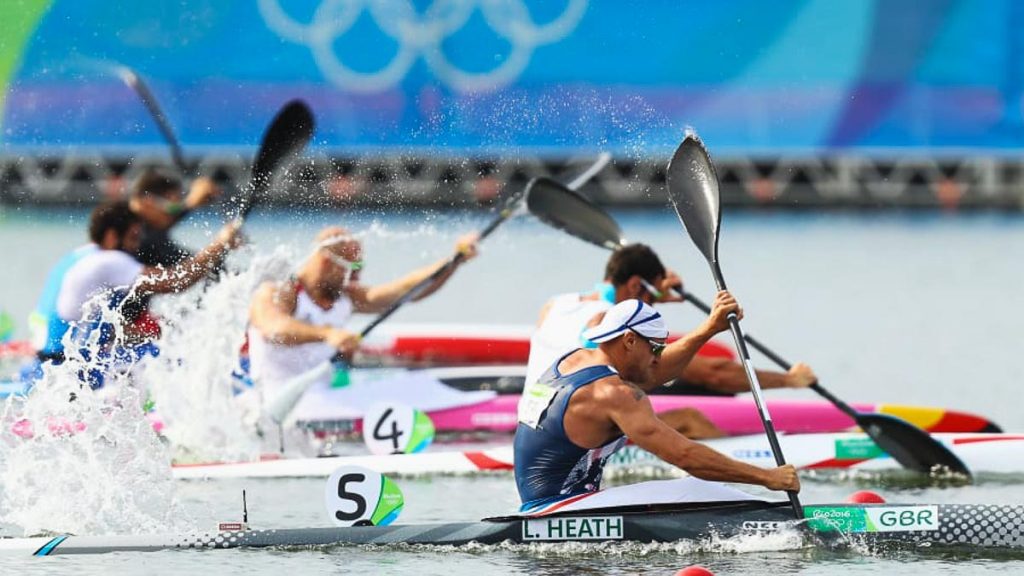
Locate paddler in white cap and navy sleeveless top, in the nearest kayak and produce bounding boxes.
[514,291,800,513]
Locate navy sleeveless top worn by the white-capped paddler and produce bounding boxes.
[514,351,626,511]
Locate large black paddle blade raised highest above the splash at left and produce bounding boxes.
[241,99,316,217]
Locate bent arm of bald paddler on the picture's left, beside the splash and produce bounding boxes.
[249,282,359,353]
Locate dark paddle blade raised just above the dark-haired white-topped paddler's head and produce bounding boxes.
[526,177,626,250]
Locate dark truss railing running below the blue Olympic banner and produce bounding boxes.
[0,154,1024,210]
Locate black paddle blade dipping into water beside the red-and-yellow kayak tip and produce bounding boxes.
[855,414,971,479]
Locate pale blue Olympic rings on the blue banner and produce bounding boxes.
[259,0,589,92]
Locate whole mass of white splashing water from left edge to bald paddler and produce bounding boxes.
[0,242,303,534]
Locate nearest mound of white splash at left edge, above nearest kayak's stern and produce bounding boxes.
[0,289,183,535]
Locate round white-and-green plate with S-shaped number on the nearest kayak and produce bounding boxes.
[324,465,404,526]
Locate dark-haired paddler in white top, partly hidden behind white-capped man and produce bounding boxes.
[525,244,817,439]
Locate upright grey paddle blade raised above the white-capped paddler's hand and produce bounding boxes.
[666,131,722,262]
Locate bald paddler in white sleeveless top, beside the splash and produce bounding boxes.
[249,227,477,392]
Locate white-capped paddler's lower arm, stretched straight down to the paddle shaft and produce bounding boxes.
[592,380,800,491]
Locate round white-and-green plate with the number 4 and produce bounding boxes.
[362,404,434,455]
